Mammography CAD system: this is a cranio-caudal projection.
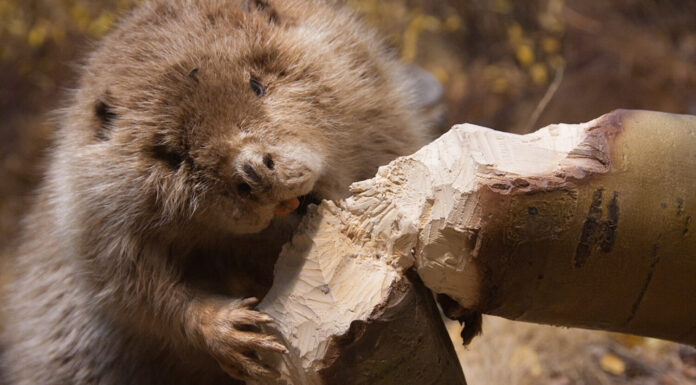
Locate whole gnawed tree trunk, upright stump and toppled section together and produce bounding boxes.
[261,111,696,384]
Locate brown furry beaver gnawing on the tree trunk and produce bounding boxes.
[0,0,440,385]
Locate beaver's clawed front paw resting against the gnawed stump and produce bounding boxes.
[203,298,287,380]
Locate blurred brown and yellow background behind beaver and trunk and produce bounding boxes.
[0,0,696,385]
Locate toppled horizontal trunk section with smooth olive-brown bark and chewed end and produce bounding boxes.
[400,107,696,345]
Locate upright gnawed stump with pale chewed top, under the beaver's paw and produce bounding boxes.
[251,202,466,385]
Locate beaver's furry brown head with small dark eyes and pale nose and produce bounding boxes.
[62,0,424,234]
